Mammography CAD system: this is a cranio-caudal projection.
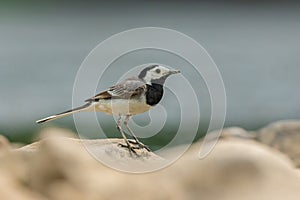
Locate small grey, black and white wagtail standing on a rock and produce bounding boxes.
[36,64,180,154]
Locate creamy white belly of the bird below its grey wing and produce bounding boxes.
[95,99,151,115]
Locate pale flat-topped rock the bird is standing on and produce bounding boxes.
[16,137,164,171]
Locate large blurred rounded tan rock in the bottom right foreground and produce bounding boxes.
[168,139,300,200]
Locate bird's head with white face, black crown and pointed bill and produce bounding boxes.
[139,65,180,85]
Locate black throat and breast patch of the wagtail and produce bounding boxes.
[146,83,164,106]
